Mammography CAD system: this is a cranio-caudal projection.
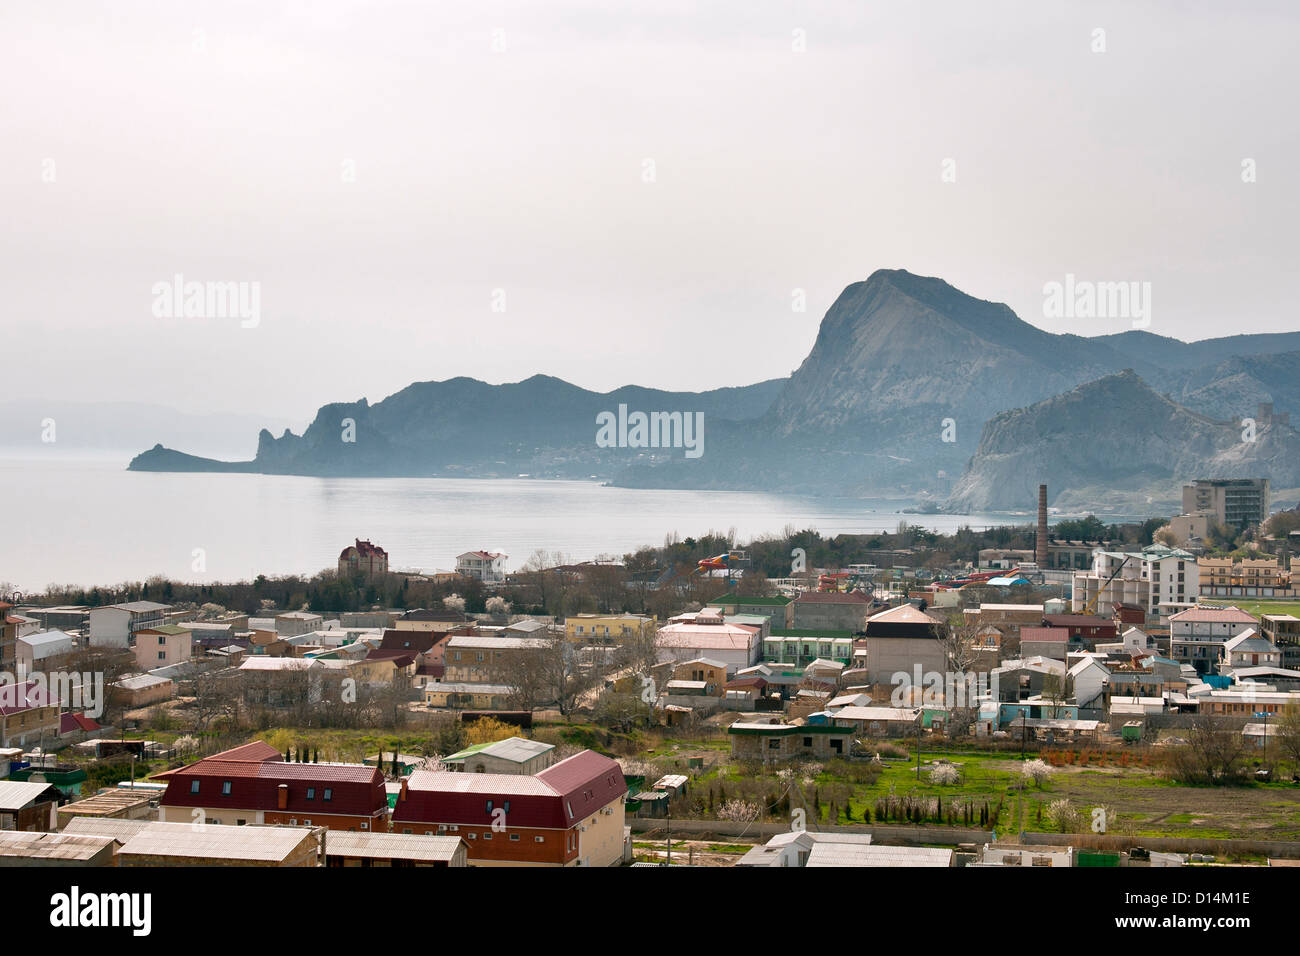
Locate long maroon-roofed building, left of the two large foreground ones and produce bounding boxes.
[153,741,389,832]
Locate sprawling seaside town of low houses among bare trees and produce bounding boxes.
[0,509,1300,868]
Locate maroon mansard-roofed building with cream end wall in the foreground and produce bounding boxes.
[393,750,628,866]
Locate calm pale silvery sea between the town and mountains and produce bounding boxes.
[0,458,1097,591]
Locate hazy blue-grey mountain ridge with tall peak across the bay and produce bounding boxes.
[130,269,1300,507]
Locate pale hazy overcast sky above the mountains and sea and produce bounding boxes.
[0,0,1300,419]
